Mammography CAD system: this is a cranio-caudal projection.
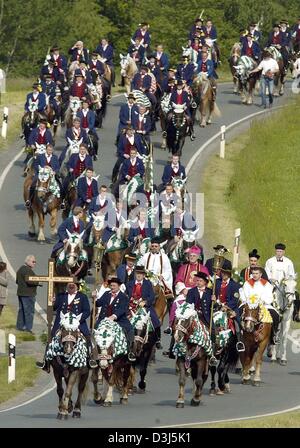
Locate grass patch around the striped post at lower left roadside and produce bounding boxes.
[0,356,39,403]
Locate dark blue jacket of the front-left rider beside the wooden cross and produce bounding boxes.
[51,292,91,337]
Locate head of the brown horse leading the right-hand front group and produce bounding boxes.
[174,303,197,343]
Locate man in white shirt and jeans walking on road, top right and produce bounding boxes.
[249,51,279,109]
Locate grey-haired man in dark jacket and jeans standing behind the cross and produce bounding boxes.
[16,255,40,334]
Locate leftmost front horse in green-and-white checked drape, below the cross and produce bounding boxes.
[46,313,89,420]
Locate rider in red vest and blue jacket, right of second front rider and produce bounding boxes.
[126,266,162,349]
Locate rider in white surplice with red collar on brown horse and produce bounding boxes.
[240,266,280,345]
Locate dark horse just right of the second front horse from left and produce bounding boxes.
[129,304,157,393]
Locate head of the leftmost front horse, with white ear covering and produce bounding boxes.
[60,312,82,356]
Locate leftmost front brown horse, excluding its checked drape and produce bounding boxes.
[50,313,89,420]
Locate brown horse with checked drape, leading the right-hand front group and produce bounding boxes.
[173,303,212,408]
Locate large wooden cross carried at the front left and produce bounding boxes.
[26,258,77,342]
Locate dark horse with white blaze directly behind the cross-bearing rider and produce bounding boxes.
[55,230,88,280]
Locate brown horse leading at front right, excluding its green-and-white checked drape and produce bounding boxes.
[174,309,208,408]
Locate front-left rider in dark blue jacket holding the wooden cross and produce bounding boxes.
[36,282,97,373]
